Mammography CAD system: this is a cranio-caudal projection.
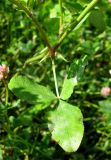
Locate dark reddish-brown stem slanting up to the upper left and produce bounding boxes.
[10,0,53,53]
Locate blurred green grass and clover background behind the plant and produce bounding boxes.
[0,0,111,160]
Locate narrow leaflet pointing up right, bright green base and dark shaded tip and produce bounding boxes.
[60,55,88,100]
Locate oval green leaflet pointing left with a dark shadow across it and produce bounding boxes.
[8,75,56,104]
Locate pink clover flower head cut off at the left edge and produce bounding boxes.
[0,64,9,81]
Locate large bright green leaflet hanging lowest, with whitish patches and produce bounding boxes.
[49,101,84,152]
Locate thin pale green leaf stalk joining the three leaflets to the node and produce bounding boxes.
[51,58,60,98]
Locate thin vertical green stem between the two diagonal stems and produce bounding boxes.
[59,0,63,34]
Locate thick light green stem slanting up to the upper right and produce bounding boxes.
[54,0,99,50]
